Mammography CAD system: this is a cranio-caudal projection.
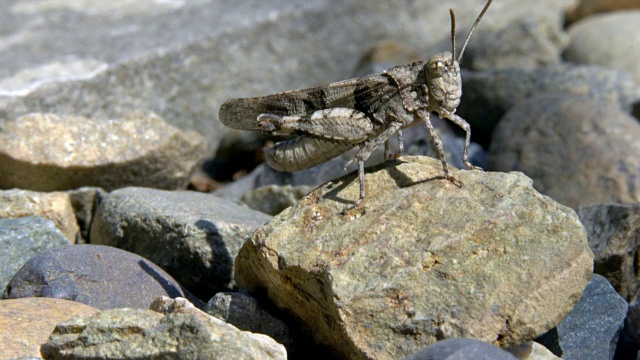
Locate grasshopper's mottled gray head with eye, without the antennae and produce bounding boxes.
[424,51,462,113]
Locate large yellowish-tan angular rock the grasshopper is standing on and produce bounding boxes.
[236,157,593,359]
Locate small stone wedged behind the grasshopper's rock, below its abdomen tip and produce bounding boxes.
[240,185,313,215]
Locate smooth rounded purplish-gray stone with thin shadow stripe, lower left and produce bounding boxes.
[3,245,204,310]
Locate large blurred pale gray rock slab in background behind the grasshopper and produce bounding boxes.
[0,0,574,158]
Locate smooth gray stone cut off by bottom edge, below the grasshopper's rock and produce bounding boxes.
[405,338,516,360]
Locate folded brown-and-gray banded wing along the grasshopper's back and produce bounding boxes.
[219,73,398,130]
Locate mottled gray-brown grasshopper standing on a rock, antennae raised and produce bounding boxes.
[219,0,492,214]
